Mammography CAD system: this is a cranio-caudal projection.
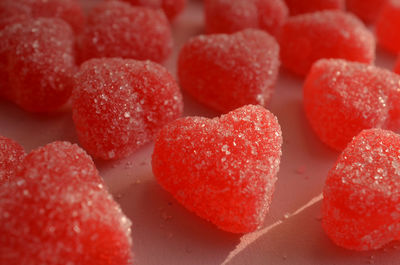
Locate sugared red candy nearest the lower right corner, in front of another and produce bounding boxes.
[322,129,400,250]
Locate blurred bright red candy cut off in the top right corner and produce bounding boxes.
[375,0,400,53]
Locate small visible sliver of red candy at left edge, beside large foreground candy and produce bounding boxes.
[0,135,25,183]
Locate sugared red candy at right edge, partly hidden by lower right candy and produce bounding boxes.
[303,59,400,150]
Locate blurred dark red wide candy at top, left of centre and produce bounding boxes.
[79,1,172,62]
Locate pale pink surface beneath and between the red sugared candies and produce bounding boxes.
[0,0,400,265]
